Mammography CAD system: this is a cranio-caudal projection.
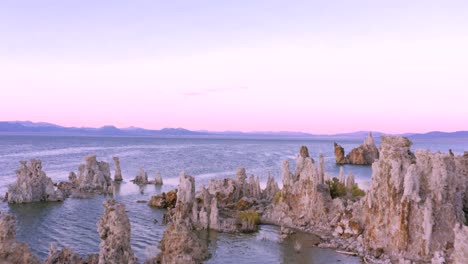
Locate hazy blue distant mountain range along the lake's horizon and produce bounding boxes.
[0,121,468,139]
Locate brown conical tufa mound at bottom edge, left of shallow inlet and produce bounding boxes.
[153,224,210,264]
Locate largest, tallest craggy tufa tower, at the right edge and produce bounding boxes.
[357,137,468,261]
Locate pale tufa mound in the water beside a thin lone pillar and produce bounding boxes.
[76,155,114,194]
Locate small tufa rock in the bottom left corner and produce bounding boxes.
[0,213,41,264]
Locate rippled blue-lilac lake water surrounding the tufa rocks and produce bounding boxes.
[0,136,468,263]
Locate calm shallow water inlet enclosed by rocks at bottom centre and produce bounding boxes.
[200,225,361,264]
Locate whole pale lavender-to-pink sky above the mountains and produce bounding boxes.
[0,0,468,134]
